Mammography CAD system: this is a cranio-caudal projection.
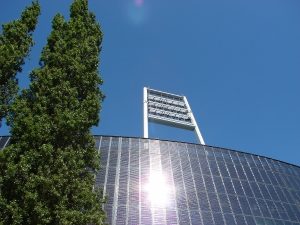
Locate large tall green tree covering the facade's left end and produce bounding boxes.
[0,0,105,225]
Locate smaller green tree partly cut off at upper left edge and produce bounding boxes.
[0,2,40,122]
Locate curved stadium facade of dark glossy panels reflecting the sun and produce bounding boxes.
[0,136,300,225]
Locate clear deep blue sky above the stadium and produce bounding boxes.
[0,0,300,165]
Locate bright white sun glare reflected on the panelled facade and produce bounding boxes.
[145,171,171,207]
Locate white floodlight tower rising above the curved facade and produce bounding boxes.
[144,87,205,145]
